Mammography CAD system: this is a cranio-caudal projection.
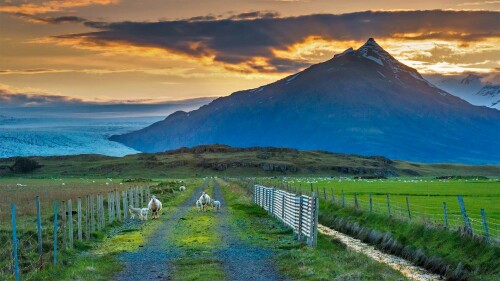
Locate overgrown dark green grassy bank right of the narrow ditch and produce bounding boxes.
[319,202,500,280]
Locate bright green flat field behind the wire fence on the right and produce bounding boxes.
[278,178,500,238]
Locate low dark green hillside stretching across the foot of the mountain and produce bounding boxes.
[0,145,500,178]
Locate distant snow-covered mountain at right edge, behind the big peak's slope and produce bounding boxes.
[428,73,500,110]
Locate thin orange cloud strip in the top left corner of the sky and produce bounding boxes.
[0,0,119,15]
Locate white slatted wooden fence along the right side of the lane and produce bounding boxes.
[253,185,319,246]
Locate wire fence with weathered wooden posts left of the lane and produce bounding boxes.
[0,186,150,280]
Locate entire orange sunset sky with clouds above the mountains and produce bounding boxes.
[0,0,500,103]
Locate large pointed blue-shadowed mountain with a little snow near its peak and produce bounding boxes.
[110,38,500,163]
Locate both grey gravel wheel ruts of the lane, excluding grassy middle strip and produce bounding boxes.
[114,183,285,281]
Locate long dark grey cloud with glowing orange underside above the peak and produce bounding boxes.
[56,10,500,72]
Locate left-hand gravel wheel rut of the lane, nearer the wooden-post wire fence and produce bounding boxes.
[114,187,201,281]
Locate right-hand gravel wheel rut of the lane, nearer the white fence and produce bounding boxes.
[214,181,286,281]
